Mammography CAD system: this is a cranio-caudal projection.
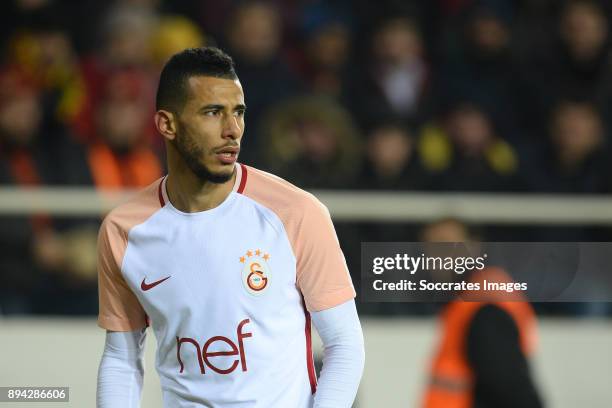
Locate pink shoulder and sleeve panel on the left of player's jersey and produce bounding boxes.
[98,179,163,331]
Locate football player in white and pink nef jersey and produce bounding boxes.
[97,48,364,408]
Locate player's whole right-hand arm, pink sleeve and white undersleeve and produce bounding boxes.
[283,194,365,408]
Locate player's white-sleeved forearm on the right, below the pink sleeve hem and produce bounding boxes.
[312,299,365,408]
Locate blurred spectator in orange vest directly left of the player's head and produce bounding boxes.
[87,71,162,189]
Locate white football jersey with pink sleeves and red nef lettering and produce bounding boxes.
[98,164,355,408]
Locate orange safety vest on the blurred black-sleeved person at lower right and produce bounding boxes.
[423,267,537,408]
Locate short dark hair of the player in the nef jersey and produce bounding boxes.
[155,47,238,112]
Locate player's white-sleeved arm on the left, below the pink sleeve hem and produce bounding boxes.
[96,328,146,408]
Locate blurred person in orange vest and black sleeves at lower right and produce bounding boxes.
[421,219,543,408]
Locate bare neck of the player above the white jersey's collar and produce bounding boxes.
[166,163,236,213]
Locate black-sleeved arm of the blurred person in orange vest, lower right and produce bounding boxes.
[467,305,542,408]
